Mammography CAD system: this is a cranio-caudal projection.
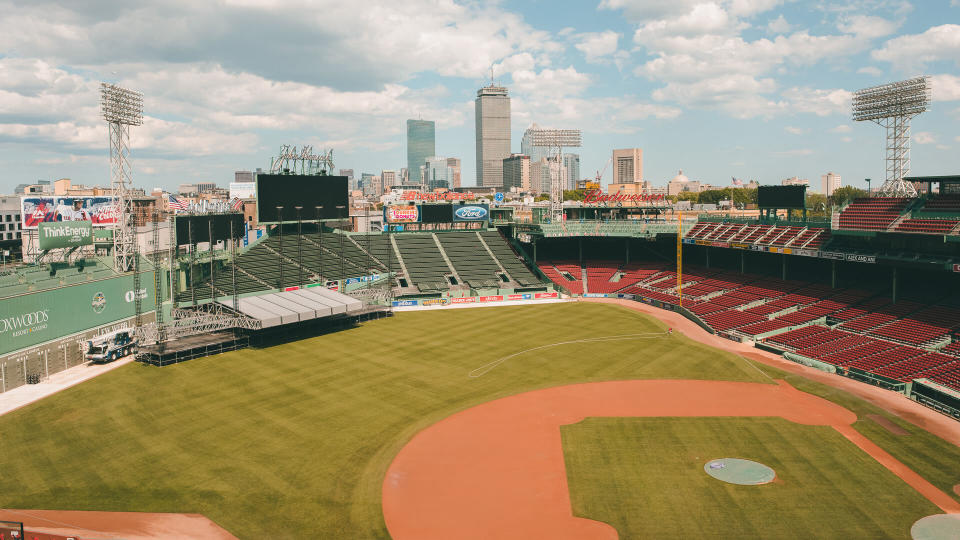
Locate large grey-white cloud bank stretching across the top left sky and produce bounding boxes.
[0,0,564,90]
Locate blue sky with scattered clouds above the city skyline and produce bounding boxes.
[0,0,960,193]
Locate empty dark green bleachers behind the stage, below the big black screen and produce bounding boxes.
[176,226,542,302]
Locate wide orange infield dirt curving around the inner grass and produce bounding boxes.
[383,380,960,540]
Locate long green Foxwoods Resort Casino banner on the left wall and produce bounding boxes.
[0,272,153,354]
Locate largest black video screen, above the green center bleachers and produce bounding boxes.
[257,174,350,223]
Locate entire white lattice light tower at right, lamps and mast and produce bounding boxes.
[853,76,930,197]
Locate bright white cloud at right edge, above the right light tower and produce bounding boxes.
[871,24,960,70]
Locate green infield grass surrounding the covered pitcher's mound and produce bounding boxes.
[561,418,941,539]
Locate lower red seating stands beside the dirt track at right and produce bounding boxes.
[541,258,960,391]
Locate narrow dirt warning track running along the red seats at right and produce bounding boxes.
[579,298,960,446]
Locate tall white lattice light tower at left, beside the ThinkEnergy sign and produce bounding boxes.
[100,83,143,272]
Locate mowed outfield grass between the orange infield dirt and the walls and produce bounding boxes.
[0,303,960,539]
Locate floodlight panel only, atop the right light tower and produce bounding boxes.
[853,76,930,122]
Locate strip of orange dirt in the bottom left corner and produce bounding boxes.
[0,509,236,540]
